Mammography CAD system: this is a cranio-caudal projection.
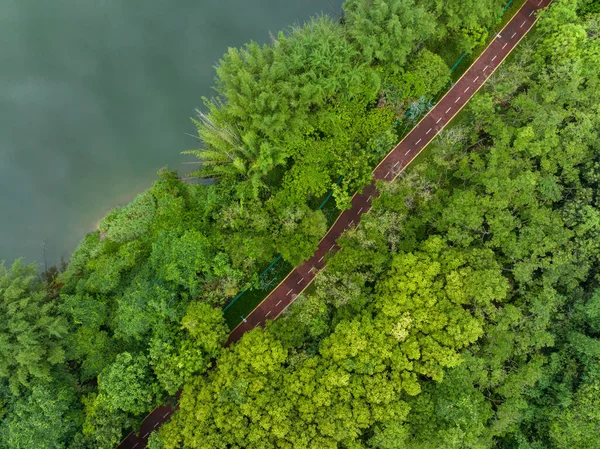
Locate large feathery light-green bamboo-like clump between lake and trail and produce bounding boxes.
[190,17,378,191]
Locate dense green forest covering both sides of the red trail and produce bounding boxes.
[0,0,600,449]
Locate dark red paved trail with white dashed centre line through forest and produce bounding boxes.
[117,0,552,449]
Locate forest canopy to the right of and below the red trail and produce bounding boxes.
[160,1,600,449]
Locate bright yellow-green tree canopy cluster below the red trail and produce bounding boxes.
[155,238,507,448]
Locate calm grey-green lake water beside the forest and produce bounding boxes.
[0,0,342,264]
